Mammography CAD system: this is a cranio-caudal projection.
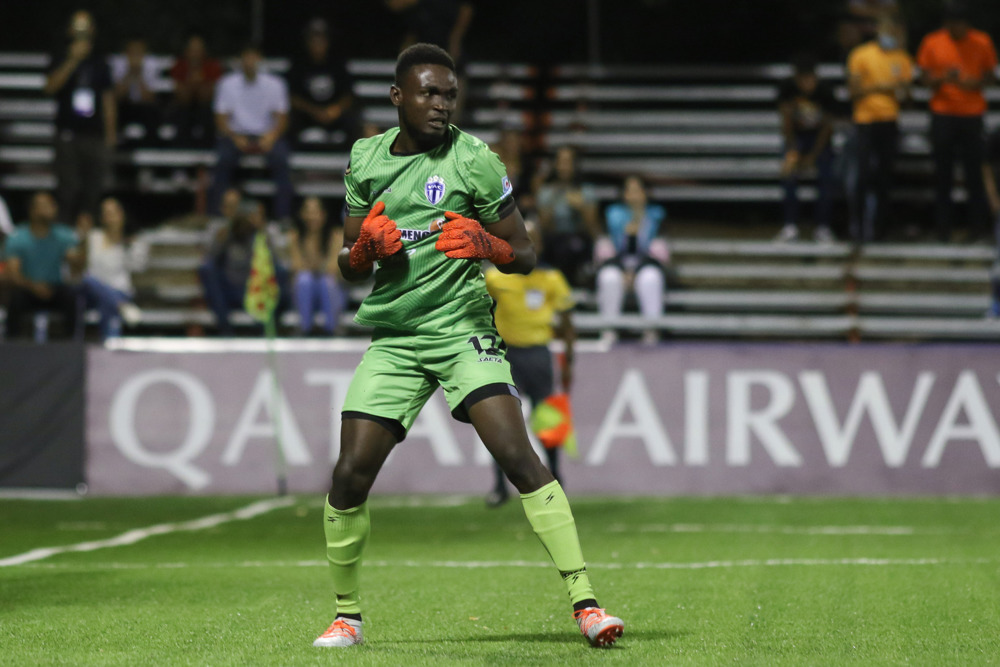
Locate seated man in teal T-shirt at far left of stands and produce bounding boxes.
[6,192,83,338]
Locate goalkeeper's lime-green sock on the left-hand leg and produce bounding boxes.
[323,499,371,614]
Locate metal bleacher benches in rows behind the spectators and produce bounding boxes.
[0,53,1000,340]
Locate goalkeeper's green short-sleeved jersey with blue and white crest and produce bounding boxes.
[344,125,514,334]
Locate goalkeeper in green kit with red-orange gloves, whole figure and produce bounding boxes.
[314,44,623,646]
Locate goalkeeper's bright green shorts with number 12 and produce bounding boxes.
[342,316,517,441]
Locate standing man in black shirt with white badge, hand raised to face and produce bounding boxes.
[44,10,118,220]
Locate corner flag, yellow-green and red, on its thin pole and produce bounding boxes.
[243,231,288,496]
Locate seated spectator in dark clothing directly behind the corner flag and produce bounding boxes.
[198,201,288,336]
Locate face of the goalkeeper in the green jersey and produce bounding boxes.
[390,65,458,145]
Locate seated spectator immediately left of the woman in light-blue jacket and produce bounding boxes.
[537,146,600,287]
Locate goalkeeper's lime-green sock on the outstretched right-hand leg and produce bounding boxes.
[521,482,594,603]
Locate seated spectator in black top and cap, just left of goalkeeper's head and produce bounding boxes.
[288,19,359,145]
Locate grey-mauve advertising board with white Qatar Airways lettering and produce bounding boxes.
[86,343,1000,495]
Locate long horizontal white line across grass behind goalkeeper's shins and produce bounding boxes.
[13,558,997,570]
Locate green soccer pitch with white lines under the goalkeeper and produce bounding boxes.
[0,497,1000,666]
